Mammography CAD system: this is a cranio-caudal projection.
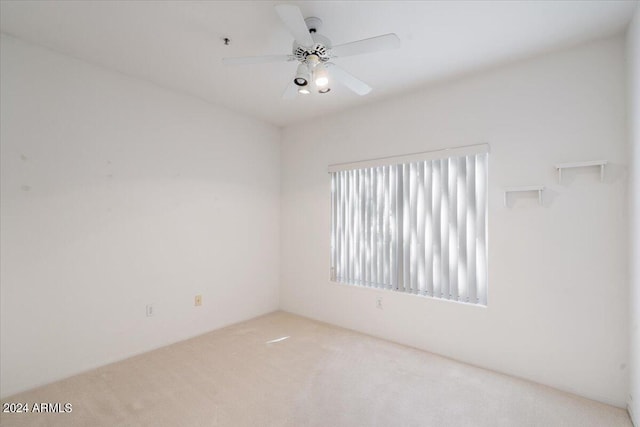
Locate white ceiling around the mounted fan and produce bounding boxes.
[0,0,637,125]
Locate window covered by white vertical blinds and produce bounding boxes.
[329,144,489,305]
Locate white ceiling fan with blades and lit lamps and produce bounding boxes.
[222,4,400,99]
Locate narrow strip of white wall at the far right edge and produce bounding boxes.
[627,3,640,426]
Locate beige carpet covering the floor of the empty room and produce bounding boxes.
[0,312,631,427]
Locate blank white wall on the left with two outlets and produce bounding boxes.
[0,36,280,396]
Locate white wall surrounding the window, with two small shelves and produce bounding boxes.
[281,38,629,407]
